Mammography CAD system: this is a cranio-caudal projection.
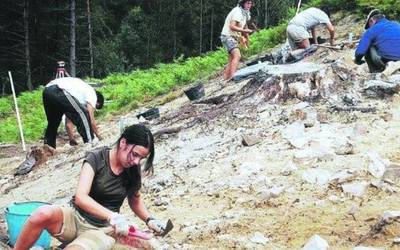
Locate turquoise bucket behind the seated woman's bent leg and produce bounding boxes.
[5,201,51,249]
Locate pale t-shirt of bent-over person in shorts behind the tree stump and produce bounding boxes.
[289,7,331,30]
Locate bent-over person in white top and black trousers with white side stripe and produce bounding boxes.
[43,77,104,148]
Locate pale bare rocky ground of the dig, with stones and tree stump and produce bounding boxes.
[0,12,400,249]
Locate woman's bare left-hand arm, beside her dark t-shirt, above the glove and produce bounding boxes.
[75,162,113,220]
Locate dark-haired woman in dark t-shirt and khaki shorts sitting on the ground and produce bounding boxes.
[14,125,164,250]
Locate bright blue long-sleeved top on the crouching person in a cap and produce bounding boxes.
[355,18,400,61]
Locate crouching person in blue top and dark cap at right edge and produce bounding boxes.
[354,9,400,73]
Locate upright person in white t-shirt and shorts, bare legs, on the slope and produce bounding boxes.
[221,0,253,80]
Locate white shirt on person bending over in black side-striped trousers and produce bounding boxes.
[46,77,97,109]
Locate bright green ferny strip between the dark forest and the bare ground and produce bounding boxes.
[0,24,285,142]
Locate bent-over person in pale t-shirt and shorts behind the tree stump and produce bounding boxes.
[286,7,335,50]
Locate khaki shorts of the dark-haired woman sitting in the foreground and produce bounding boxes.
[54,207,115,250]
